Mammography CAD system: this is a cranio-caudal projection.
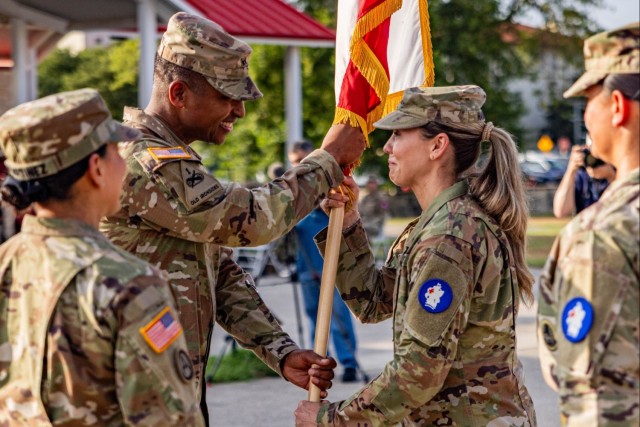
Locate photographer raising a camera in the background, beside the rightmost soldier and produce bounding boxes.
[553,145,616,218]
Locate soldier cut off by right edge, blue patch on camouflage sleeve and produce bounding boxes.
[538,23,640,427]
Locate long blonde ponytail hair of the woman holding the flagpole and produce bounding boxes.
[421,122,534,303]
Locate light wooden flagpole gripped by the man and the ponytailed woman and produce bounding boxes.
[309,208,344,402]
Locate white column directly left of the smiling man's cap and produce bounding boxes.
[136,0,158,108]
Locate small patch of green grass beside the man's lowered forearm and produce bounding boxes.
[205,349,278,383]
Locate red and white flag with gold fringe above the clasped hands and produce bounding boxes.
[333,0,434,142]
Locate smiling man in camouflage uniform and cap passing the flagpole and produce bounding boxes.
[101,12,364,422]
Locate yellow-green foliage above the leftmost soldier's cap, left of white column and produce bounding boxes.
[38,39,139,120]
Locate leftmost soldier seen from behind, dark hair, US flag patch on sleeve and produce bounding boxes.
[0,89,204,426]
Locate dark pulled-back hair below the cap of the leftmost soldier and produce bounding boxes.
[0,144,107,210]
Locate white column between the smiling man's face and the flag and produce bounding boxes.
[284,46,302,159]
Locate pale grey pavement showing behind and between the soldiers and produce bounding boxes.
[207,272,560,427]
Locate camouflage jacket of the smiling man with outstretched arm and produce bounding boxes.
[101,108,343,390]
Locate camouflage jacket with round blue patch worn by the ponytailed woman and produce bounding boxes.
[318,181,536,427]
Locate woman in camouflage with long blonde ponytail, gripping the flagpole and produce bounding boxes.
[296,86,536,426]
